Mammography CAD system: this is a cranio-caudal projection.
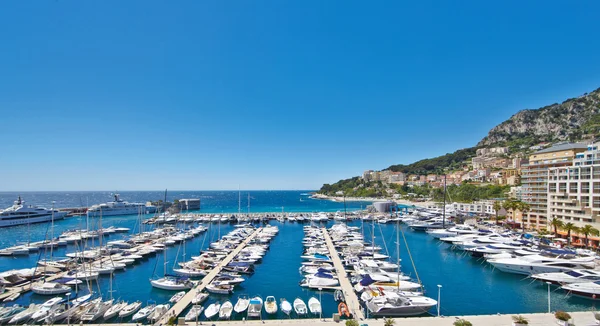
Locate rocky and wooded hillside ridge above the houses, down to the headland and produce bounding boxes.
[319,88,600,197]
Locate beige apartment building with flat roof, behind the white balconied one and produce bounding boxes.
[521,143,587,229]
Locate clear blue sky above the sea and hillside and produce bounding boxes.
[0,0,600,191]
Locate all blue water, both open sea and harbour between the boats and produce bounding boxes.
[0,191,595,319]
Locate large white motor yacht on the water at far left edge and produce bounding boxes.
[0,196,67,227]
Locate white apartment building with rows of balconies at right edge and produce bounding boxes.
[547,143,600,229]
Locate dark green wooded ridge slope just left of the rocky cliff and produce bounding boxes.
[386,147,477,175]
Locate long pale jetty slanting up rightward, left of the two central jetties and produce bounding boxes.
[154,228,263,326]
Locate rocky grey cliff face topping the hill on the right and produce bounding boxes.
[477,88,600,147]
